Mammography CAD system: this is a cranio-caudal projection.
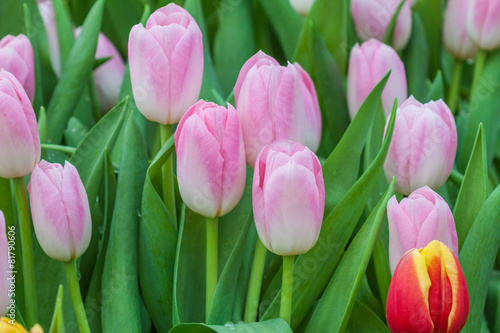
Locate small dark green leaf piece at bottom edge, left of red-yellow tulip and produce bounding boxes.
[345,301,391,333]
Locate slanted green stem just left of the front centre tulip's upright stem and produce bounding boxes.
[245,238,267,323]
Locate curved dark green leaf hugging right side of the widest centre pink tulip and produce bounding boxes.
[294,20,349,156]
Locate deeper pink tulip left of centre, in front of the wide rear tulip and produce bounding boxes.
[175,100,246,218]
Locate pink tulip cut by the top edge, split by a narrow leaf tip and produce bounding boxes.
[351,0,411,51]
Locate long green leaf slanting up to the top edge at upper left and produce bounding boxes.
[47,0,104,144]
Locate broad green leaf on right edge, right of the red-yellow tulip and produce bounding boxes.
[458,186,500,333]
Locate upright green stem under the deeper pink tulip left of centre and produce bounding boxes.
[205,217,219,320]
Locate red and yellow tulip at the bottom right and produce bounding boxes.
[387,240,469,333]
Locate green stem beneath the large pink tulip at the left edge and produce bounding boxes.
[13,177,38,326]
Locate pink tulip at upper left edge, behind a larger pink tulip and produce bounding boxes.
[0,34,35,100]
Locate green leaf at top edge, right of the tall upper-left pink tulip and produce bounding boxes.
[213,0,257,96]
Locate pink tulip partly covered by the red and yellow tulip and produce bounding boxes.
[387,186,458,272]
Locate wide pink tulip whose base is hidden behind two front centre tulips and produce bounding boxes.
[234,51,321,167]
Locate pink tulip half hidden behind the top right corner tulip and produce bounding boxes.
[443,0,477,60]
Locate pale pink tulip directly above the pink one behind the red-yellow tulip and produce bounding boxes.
[384,96,457,195]
